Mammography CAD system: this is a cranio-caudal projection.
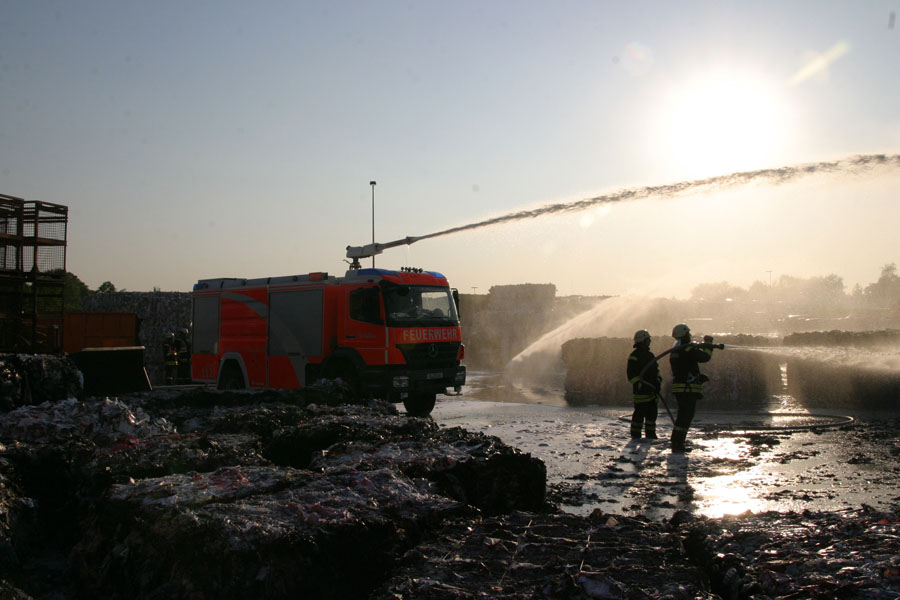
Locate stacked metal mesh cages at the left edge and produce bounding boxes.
[0,194,69,353]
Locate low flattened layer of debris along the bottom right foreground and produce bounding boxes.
[370,508,900,600]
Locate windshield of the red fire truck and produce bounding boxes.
[384,284,459,326]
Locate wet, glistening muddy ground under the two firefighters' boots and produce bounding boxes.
[434,399,900,520]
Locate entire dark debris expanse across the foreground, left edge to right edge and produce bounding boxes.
[0,385,900,600]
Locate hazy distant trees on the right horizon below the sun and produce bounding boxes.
[691,263,900,308]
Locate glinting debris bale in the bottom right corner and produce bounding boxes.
[675,505,900,600]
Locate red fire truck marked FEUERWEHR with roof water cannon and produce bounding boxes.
[191,238,466,416]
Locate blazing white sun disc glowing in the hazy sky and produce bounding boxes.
[660,73,785,177]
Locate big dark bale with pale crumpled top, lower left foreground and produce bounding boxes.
[73,466,464,598]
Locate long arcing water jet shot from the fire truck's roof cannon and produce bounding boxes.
[416,154,900,240]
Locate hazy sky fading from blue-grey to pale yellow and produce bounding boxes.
[0,0,900,296]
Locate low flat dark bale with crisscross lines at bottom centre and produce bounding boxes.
[370,511,705,600]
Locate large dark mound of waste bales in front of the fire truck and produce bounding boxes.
[0,391,546,599]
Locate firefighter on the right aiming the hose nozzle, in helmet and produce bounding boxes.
[669,323,713,453]
